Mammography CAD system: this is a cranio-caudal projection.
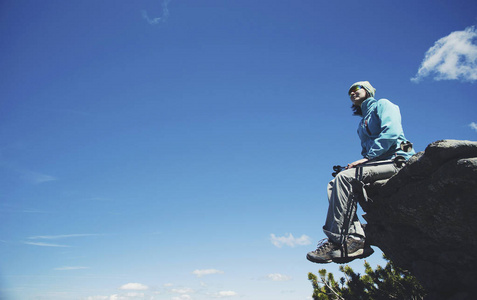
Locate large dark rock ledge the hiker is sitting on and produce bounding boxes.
[361,140,477,300]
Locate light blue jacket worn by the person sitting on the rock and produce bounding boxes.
[358,97,416,160]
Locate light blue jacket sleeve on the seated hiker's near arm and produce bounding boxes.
[365,99,403,159]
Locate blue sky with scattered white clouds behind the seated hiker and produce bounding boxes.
[0,0,477,300]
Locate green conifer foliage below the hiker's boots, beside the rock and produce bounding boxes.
[308,256,426,300]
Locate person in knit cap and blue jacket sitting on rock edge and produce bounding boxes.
[307,81,415,263]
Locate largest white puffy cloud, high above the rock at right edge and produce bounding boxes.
[411,26,477,82]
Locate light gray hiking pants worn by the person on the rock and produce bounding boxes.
[323,160,399,244]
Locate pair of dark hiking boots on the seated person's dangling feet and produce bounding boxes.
[306,236,374,264]
